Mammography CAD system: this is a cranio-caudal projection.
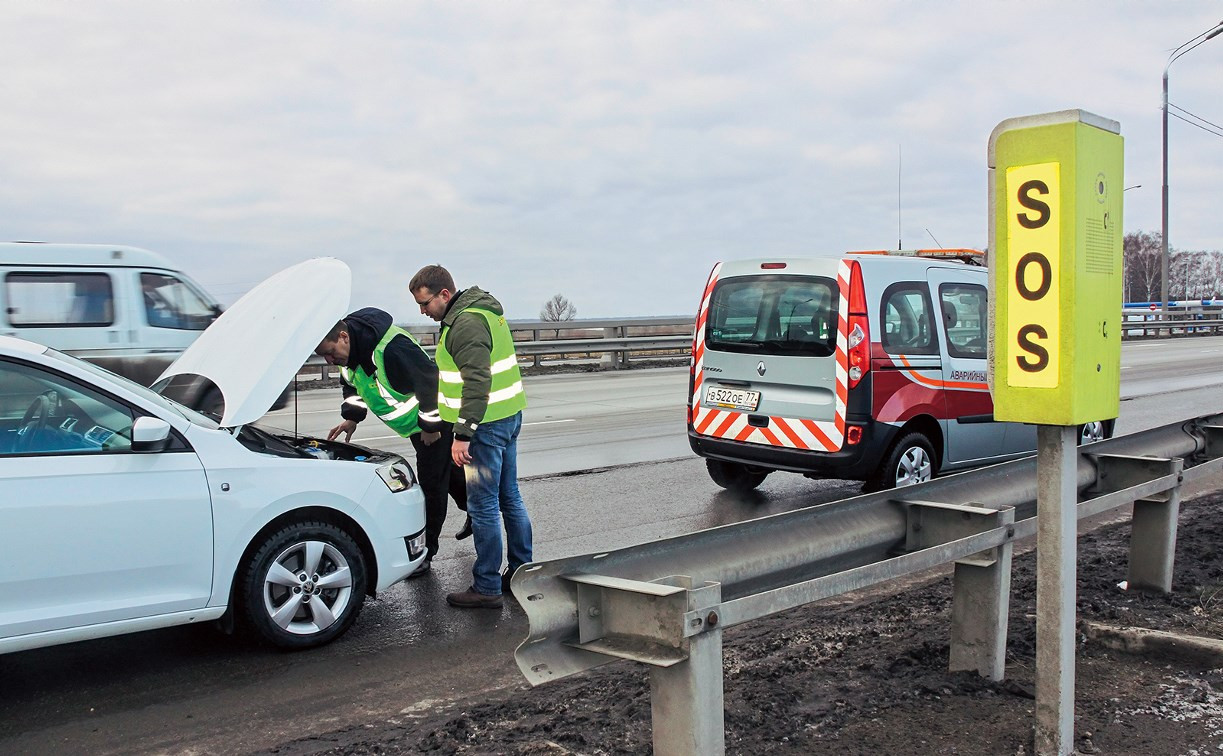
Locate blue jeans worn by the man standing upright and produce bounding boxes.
[464,412,531,596]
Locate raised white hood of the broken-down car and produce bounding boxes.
[158,257,352,427]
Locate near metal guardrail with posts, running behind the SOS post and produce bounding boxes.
[511,415,1223,755]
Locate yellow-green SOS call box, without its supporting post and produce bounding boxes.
[989,110,1124,426]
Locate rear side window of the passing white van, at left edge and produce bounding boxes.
[5,273,115,328]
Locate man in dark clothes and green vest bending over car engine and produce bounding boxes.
[314,307,471,579]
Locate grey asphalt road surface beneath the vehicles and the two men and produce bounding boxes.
[0,338,1223,754]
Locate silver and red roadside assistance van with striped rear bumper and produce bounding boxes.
[687,250,1113,491]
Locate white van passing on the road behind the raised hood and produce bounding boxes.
[0,242,221,410]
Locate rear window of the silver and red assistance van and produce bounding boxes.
[704,275,839,357]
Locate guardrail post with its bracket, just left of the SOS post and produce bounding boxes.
[904,502,1015,680]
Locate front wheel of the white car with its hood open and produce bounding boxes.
[240,522,366,650]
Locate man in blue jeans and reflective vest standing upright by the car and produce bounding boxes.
[407,265,531,609]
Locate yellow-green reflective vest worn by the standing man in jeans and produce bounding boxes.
[434,307,527,429]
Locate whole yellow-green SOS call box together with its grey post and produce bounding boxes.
[988,110,1123,755]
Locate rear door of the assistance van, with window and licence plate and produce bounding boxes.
[692,258,844,451]
